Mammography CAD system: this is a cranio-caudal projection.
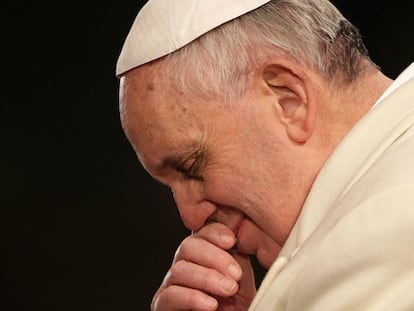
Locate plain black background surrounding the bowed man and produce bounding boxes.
[4,0,414,311]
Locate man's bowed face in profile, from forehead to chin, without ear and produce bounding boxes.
[120,65,312,267]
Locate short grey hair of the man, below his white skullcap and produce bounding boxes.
[163,0,376,99]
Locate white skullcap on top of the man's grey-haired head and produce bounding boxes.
[116,0,270,76]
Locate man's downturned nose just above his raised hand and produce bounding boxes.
[171,181,217,231]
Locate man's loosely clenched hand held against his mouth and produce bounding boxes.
[151,223,256,311]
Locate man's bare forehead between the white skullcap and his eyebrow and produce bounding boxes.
[120,63,209,168]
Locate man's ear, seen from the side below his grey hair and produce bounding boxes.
[262,62,315,144]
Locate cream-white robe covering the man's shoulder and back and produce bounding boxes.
[249,66,414,311]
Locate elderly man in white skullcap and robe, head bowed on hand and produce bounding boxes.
[117,0,414,311]
